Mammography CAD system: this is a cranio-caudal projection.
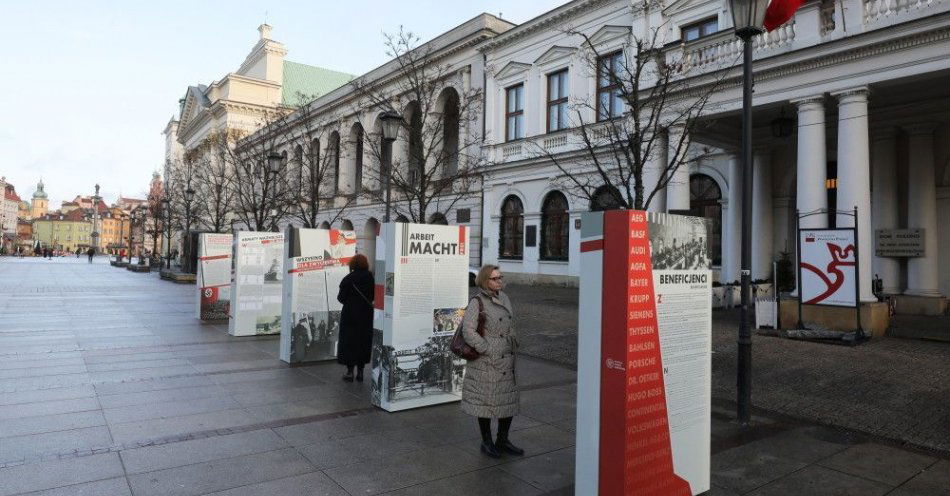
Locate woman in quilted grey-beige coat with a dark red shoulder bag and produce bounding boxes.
[462,265,524,458]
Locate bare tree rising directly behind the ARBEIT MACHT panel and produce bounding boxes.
[351,27,487,223]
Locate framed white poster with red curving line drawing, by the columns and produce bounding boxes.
[798,228,858,307]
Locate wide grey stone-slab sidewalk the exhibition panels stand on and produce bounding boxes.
[0,258,950,496]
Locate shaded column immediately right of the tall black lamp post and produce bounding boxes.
[752,149,774,281]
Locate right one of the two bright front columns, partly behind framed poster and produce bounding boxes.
[834,87,877,301]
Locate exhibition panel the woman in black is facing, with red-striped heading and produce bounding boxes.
[280,227,356,363]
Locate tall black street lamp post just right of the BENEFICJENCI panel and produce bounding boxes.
[729,0,769,424]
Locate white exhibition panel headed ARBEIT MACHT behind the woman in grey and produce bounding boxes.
[372,223,469,412]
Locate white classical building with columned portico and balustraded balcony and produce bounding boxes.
[479,0,950,311]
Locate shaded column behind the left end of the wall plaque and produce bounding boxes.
[871,127,900,294]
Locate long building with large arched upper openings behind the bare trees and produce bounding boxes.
[252,14,514,264]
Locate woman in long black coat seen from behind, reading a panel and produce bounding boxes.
[336,255,375,382]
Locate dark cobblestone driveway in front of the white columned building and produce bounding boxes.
[508,286,950,458]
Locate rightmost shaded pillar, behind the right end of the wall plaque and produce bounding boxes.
[904,123,940,296]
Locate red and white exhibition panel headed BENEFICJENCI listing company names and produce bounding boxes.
[575,210,712,496]
